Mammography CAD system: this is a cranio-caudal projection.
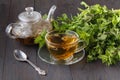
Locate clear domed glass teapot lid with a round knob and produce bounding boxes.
[18,7,41,22]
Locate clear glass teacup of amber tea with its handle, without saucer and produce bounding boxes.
[45,30,86,62]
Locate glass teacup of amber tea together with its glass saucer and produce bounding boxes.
[38,31,85,65]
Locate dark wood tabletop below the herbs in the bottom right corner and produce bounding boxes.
[70,60,120,80]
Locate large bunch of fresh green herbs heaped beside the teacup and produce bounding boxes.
[34,2,120,65]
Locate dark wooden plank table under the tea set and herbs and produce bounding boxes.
[0,0,120,80]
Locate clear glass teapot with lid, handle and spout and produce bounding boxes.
[6,5,56,44]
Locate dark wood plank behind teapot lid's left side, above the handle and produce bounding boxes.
[9,0,34,23]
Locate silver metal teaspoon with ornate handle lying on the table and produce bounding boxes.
[14,49,46,75]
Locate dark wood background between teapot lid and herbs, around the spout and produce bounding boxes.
[35,0,82,17]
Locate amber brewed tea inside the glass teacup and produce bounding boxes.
[47,34,78,60]
